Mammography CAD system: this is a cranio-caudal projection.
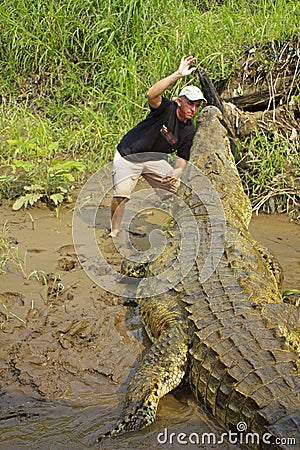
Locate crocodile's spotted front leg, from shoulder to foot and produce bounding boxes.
[98,294,191,442]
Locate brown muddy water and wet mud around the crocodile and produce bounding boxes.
[0,198,300,450]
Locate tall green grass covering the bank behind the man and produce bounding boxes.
[0,0,300,211]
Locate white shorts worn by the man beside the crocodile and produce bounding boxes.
[112,150,180,198]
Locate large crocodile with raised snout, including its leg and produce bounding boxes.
[100,106,300,448]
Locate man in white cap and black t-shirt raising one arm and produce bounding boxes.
[110,56,206,237]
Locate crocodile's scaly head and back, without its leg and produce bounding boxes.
[183,110,300,439]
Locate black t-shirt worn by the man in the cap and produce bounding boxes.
[117,97,196,161]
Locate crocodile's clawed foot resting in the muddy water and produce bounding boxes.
[97,405,156,442]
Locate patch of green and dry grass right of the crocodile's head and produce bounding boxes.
[238,130,300,217]
